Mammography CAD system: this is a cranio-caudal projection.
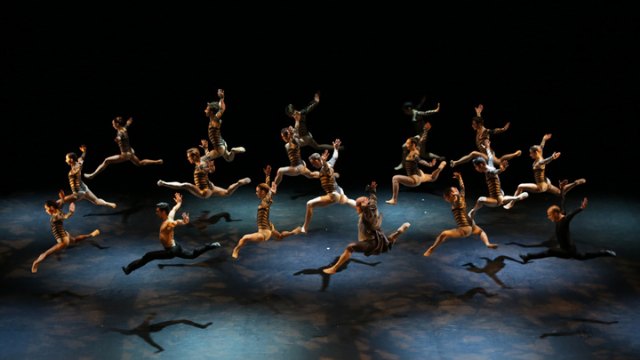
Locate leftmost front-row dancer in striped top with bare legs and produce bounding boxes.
[31,197,100,273]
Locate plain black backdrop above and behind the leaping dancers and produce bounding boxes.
[1,2,640,196]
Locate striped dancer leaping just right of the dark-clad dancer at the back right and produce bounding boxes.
[449,104,522,168]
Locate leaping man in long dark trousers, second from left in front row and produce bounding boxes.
[122,193,220,275]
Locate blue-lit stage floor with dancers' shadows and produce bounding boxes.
[0,183,640,359]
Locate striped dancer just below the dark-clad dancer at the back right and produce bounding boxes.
[386,137,447,205]
